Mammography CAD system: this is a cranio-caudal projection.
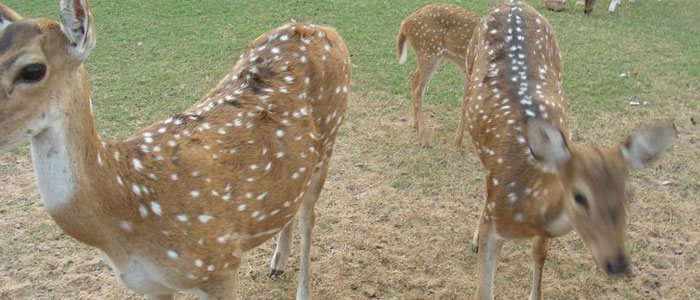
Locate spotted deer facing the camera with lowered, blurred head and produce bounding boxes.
[457,2,675,299]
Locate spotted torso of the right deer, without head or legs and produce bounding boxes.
[467,3,568,234]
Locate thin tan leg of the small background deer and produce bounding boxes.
[413,60,440,147]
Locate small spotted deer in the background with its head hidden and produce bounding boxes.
[397,4,479,147]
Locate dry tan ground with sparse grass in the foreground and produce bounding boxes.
[0,94,700,299]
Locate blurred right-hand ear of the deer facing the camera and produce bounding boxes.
[620,124,676,169]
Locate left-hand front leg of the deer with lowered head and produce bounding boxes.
[475,214,503,300]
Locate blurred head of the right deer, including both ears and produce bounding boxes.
[527,120,675,275]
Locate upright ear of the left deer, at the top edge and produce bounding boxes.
[59,0,96,61]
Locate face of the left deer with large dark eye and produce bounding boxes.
[0,1,94,153]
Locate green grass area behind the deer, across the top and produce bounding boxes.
[7,0,700,141]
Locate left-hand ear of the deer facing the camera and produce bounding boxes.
[527,119,571,170]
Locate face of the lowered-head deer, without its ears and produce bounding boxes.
[561,148,628,274]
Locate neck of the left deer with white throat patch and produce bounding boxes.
[31,68,109,245]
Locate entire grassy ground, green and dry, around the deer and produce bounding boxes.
[0,0,700,299]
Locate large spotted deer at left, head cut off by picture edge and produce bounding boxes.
[0,0,350,299]
